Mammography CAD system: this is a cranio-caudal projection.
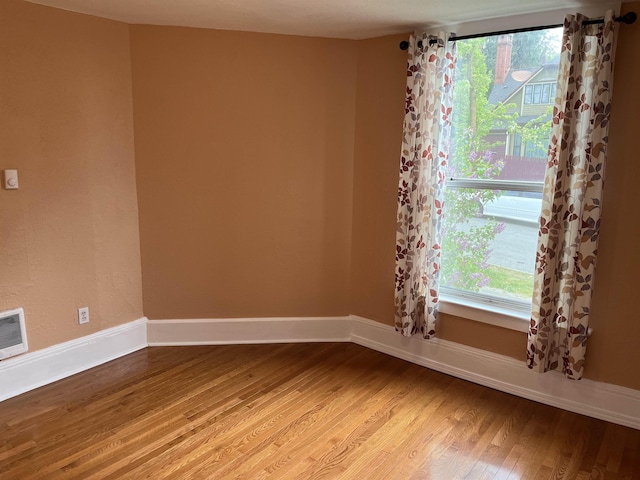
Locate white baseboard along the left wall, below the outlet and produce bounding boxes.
[0,318,147,401]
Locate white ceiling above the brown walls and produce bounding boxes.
[23,0,624,39]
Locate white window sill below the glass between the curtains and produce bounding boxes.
[439,294,530,333]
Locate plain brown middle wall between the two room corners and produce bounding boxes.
[131,26,357,319]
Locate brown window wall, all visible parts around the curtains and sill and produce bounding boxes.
[351,2,640,389]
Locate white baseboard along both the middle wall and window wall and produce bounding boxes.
[147,315,640,429]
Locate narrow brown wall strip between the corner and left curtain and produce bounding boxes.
[351,35,407,324]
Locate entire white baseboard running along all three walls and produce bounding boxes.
[0,315,640,429]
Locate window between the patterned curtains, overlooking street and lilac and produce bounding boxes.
[440,29,561,316]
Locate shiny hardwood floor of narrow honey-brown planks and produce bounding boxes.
[0,343,640,480]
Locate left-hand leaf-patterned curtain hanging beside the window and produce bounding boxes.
[395,33,456,338]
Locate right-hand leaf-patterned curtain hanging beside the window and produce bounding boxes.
[527,11,614,379]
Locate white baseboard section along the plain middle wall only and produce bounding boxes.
[147,317,351,346]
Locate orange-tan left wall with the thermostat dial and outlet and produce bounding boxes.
[0,0,142,350]
